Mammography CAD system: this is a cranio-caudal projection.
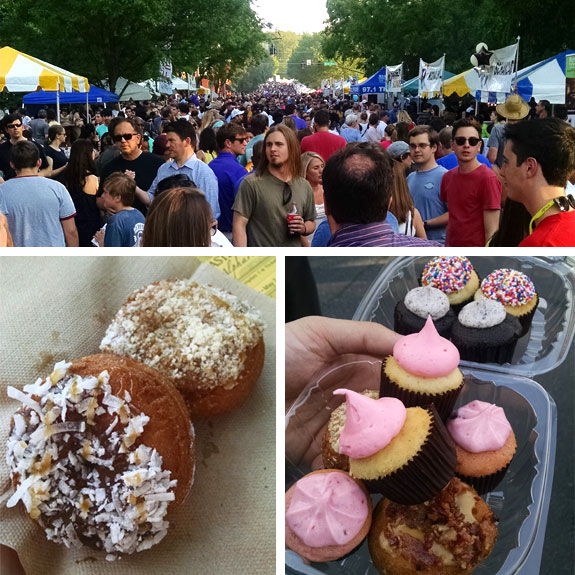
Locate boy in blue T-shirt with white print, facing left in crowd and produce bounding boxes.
[94,172,145,248]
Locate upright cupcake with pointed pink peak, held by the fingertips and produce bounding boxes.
[379,316,463,421]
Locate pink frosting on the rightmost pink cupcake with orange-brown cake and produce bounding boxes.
[447,400,512,453]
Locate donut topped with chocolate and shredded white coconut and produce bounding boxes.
[7,354,195,559]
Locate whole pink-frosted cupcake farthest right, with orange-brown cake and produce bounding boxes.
[447,400,517,493]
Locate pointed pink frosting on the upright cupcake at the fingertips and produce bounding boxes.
[393,316,459,378]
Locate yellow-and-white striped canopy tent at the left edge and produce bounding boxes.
[0,46,89,118]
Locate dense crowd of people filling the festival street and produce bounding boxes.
[0,84,575,247]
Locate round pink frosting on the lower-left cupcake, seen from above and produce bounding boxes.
[286,472,369,547]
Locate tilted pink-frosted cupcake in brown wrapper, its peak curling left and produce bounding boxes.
[334,389,456,505]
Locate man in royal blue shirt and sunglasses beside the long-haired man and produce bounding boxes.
[209,122,248,240]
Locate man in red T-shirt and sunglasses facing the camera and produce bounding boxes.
[439,118,501,247]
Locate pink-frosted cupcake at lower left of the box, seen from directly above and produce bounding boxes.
[285,469,372,562]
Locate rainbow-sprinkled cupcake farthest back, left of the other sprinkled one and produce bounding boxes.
[420,256,479,313]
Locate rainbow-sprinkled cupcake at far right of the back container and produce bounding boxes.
[475,268,539,336]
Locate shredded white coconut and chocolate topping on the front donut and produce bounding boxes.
[6,362,177,560]
